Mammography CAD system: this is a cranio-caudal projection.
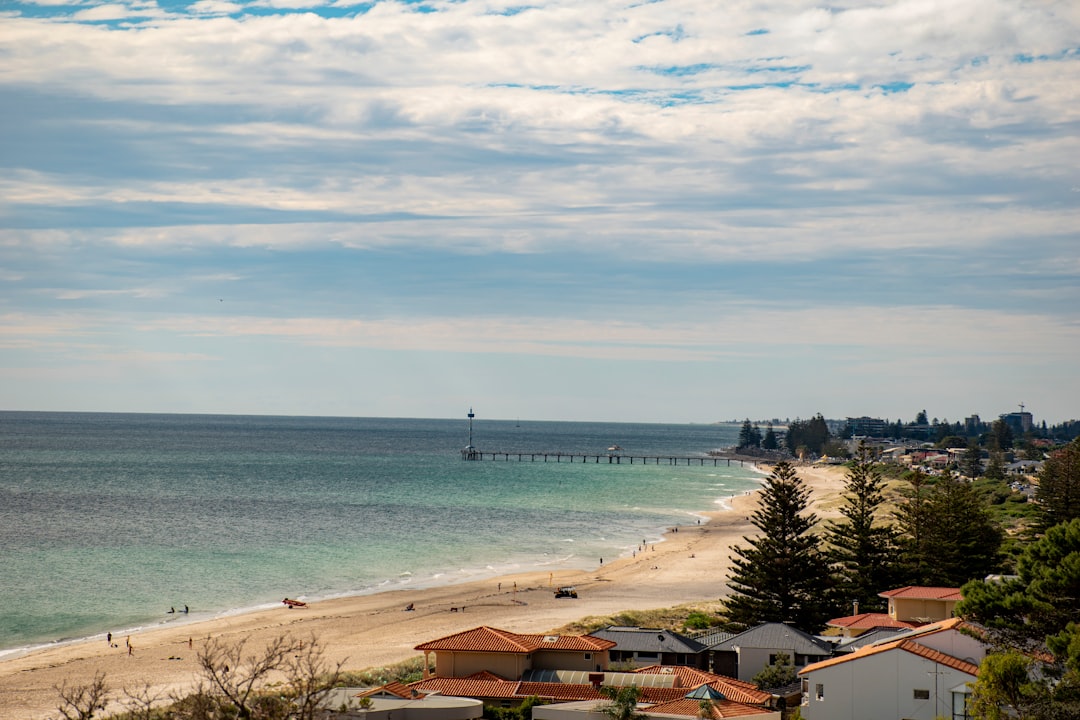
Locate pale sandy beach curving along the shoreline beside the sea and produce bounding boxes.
[0,466,845,720]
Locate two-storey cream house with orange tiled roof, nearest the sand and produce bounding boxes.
[416,626,615,680]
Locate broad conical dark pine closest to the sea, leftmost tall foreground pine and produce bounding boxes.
[725,462,828,630]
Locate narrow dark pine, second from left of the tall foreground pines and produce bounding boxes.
[824,443,897,611]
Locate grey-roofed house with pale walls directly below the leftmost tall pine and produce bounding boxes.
[710,623,833,682]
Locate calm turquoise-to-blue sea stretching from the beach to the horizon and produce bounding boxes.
[0,412,758,656]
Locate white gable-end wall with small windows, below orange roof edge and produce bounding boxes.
[802,649,975,720]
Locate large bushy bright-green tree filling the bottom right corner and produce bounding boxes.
[956,518,1080,720]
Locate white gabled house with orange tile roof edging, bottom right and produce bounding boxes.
[799,617,986,720]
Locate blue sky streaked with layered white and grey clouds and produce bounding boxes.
[0,0,1080,424]
